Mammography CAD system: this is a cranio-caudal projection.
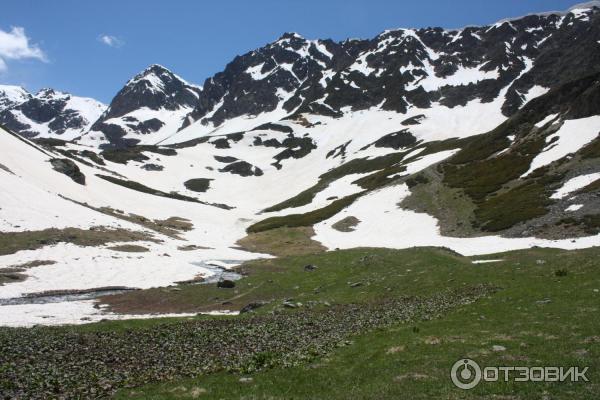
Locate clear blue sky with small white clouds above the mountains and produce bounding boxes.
[0,0,577,102]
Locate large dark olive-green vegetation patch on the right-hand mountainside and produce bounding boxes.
[436,117,562,232]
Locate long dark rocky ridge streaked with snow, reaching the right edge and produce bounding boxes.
[167,3,600,143]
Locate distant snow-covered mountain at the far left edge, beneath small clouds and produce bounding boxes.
[0,86,106,140]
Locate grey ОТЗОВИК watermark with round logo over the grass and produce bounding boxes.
[450,358,589,390]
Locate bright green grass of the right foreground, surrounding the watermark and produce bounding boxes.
[105,245,600,399]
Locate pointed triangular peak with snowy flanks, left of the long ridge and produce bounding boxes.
[80,64,202,145]
